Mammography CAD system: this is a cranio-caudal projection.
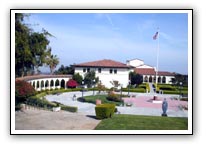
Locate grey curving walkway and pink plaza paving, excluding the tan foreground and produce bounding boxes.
[46,91,188,117]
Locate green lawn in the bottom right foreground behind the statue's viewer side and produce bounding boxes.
[95,114,188,130]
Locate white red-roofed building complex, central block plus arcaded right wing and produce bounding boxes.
[74,59,174,88]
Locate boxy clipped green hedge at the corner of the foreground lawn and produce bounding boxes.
[95,104,115,119]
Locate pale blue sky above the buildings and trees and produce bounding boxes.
[26,11,188,74]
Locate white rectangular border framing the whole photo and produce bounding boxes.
[10,9,193,135]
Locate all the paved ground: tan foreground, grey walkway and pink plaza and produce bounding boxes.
[15,92,188,130]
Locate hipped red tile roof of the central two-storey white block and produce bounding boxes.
[74,59,132,68]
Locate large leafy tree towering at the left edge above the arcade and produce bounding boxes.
[15,13,55,77]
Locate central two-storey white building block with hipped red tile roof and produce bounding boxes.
[74,59,133,88]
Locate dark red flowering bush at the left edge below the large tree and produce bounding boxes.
[15,80,36,103]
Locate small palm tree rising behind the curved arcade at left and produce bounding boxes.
[46,55,59,74]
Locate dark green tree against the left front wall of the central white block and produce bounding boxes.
[84,71,99,88]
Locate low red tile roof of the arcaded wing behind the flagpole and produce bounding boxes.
[134,68,174,76]
